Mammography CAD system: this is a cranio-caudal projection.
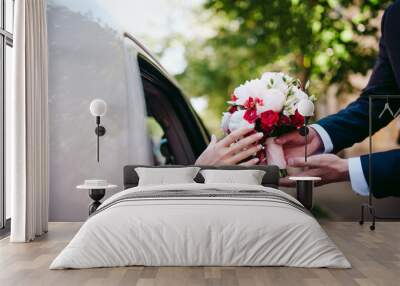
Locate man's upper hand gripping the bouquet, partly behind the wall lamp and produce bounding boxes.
[275,127,324,161]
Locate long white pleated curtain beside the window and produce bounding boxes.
[6,0,49,242]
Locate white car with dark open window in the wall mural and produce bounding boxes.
[47,0,209,221]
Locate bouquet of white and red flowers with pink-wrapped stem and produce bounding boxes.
[221,72,314,169]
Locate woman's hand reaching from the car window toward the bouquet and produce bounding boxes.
[195,128,263,166]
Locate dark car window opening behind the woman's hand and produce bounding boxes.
[138,54,208,165]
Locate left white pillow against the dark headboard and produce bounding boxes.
[135,167,200,186]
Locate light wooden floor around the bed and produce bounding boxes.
[0,222,400,286]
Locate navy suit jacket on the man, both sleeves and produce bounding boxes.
[317,0,400,197]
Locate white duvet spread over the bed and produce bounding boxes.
[50,184,350,269]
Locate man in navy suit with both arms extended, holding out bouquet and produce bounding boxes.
[276,0,400,198]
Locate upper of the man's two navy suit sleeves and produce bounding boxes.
[317,1,400,153]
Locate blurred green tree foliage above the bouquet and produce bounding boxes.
[177,0,392,134]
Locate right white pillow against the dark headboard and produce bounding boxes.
[200,170,265,185]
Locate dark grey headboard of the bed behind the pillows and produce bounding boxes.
[124,165,279,189]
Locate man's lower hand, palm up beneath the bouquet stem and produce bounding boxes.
[279,154,350,187]
